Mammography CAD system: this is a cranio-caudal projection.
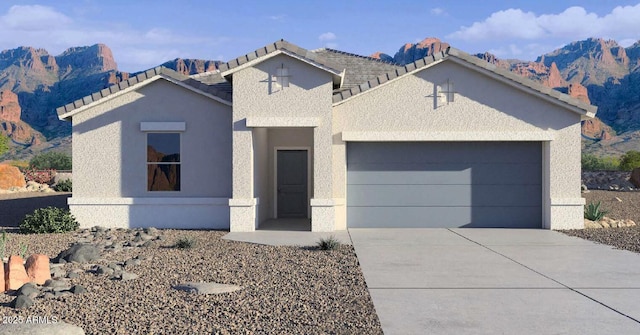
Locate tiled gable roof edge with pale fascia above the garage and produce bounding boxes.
[333,47,598,118]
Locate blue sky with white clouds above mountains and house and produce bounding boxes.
[0,0,640,72]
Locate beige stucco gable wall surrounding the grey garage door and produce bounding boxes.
[333,61,582,229]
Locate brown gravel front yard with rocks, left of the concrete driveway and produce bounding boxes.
[0,230,382,334]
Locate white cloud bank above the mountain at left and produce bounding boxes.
[0,5,229,72]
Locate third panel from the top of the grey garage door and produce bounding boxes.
[347,185,542,206]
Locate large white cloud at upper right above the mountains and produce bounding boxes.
[447,4,640,41]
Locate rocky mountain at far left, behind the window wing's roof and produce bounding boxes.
[0,44,128,159]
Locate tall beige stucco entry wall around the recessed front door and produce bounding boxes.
[230,55,333,231]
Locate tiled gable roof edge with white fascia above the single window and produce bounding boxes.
[56,66,232,119]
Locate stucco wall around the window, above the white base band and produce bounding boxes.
[73,79,231,198]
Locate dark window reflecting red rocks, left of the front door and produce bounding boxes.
[147,133,180,191]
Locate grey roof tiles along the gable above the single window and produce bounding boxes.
[56,66,232,116]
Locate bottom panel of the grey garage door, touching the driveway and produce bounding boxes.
[347,207,540,228]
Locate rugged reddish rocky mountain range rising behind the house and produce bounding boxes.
[0,37,640,159]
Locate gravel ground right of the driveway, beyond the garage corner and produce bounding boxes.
[562,191,640,253]
